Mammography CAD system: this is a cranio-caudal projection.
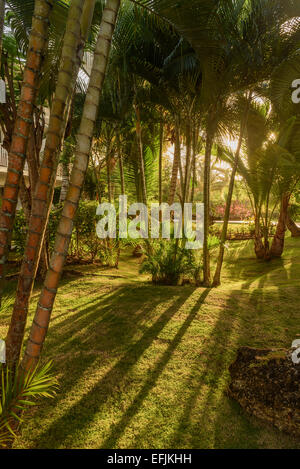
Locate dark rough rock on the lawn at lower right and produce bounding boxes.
[228,347,300,436]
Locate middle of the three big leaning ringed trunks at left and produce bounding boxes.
[6,0,91,364]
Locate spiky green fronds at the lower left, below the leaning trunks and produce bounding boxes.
[0,362,58,447]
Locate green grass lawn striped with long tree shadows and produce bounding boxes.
[0,238,300,449]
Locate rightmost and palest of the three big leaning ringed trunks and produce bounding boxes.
[23,0,120,369]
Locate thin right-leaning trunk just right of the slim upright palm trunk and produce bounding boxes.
[213,94,252,287]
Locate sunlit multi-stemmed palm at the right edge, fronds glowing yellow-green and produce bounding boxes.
[238,108,300,260]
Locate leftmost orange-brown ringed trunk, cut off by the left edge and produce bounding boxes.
[0,0,53,295]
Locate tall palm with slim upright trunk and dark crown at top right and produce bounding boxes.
[139,0,297,286]
